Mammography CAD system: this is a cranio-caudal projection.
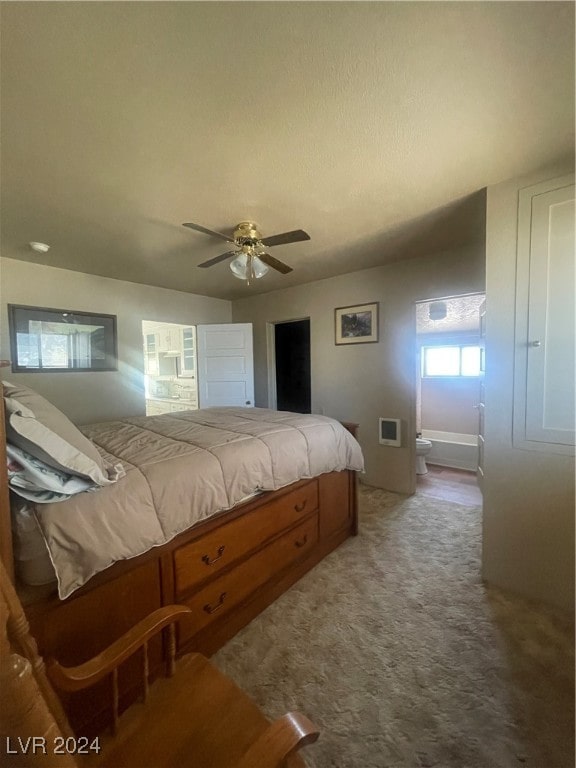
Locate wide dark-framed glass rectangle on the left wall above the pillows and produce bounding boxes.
[8,304,117,373]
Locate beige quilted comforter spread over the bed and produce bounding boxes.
[36,408,364,599]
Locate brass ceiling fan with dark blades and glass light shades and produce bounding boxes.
[182,221,310,283]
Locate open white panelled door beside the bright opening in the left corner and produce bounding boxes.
[197,323,254,408]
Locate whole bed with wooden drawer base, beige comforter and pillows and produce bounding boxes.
[0,385,363,733]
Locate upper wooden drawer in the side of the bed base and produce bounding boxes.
[174,479,318,599]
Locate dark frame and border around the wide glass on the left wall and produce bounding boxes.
[8,304,118,373]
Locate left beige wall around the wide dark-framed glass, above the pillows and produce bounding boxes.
[0,258,231,424]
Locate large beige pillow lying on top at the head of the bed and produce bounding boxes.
[2,381,115,485]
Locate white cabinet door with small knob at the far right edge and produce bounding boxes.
[515,177,576,447]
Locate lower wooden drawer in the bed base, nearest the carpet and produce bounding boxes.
[179,514,318,645]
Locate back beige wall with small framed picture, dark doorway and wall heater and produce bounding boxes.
[232,245,484,493]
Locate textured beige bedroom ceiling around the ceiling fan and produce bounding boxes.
[0,2,574,298]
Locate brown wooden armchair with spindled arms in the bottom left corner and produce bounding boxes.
[0,563,318,768]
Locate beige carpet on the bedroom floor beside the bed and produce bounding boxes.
[214,487,574,768]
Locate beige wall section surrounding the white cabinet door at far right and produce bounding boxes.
[483,162,574,611]
